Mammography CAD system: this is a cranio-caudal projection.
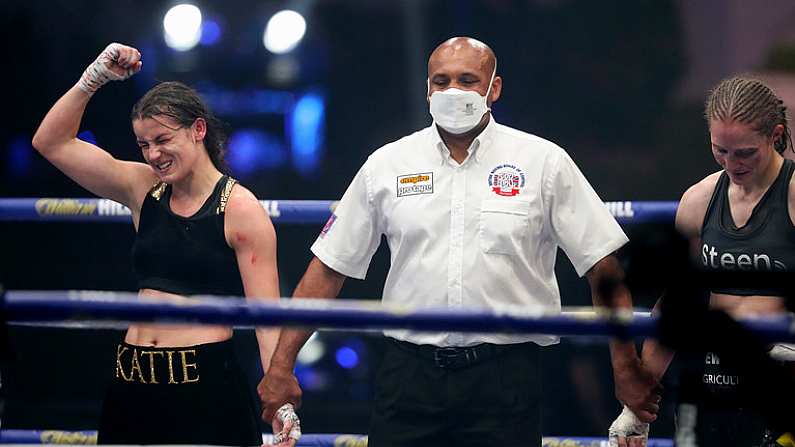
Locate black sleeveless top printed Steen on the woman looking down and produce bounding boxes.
[699,160,795,296]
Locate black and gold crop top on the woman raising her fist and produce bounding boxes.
[132,176,244,296]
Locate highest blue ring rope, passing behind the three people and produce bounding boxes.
[0,198,678,224]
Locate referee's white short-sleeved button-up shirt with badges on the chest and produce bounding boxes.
[312,118,628,346]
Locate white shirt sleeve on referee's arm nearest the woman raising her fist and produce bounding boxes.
[311,161,381,279]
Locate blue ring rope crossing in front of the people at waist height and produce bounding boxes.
[2,290,795,342]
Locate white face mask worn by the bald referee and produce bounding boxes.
[428,67,497,134]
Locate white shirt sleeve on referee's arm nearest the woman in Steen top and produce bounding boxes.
[542,148,629,276]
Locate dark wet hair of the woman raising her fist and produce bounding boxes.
[130,82,229,173]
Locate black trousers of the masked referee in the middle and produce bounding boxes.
[368,338,541,447]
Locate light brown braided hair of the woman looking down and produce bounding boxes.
[704,77,795,154]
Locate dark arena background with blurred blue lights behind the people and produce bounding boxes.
[0,0,795,437]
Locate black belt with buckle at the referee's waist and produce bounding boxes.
[389,338,534,369]
